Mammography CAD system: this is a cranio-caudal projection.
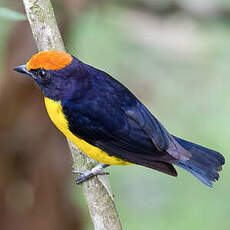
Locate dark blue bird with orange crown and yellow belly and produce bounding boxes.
[14,50,225,187]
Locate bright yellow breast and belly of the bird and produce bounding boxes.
[45,97,130,165]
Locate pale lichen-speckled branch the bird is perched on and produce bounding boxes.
[23,0,122,230]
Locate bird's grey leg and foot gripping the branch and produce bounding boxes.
[72,164,109,184]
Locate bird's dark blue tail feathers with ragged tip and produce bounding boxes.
[172,137,225,187]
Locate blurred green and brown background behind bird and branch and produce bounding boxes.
[0,0,230,230]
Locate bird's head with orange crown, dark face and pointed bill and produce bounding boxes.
[14,50,80,100]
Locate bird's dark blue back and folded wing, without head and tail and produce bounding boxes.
[62,70,191,175]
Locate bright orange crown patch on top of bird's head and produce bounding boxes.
[26,50,73,70]
